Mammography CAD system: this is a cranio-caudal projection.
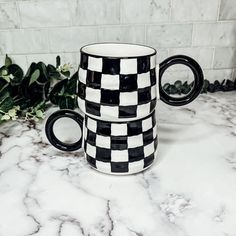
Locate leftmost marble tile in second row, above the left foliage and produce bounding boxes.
[0,29,49,54]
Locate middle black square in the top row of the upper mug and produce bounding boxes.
[102,58,120,75]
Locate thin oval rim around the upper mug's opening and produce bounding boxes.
[80,42,157,59]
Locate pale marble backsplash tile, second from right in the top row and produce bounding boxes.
[171,0,219,21]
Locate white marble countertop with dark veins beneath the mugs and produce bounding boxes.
[0,92,236,236]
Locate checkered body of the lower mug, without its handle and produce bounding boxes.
[84,111,157,174]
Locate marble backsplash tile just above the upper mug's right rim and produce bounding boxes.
[147,24,193,47]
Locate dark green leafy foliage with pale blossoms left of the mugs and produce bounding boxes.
[0,55,78,123]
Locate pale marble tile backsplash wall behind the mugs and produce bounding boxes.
[0,0,236,81]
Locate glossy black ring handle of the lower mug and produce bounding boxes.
[45,109,84,152]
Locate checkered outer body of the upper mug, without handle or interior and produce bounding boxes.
[78,53,157,121]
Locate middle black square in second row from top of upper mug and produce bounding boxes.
[120,74,138,92]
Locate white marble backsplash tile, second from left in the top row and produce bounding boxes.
[18,0,71,27]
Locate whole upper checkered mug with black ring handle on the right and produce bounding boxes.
[78,43,203,121]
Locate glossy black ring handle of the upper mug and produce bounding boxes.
[159,55,204,106]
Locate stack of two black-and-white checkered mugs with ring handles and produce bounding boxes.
[46,43,203,174]
